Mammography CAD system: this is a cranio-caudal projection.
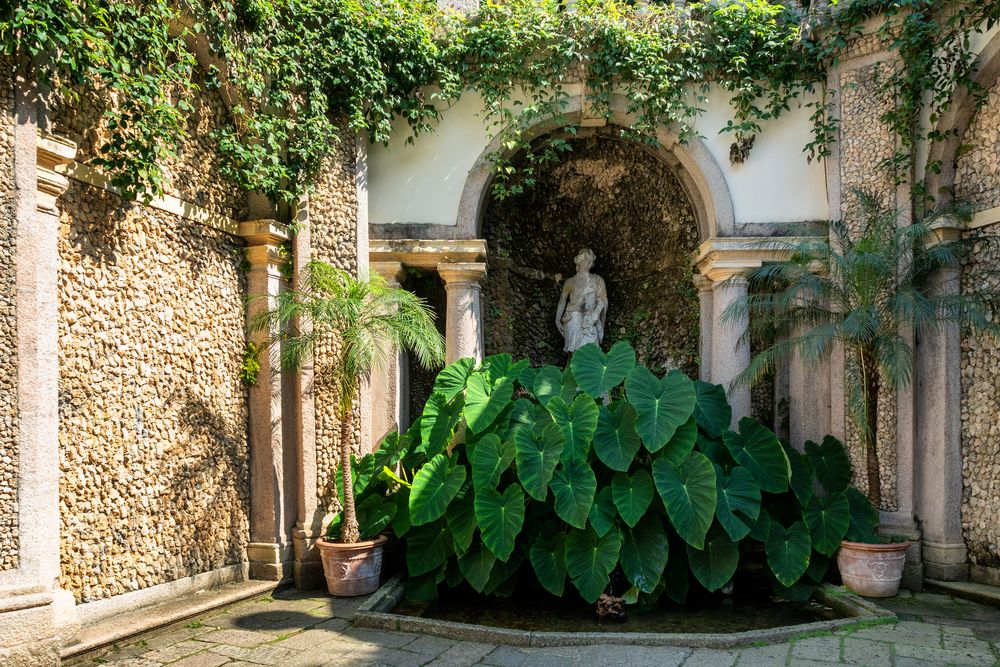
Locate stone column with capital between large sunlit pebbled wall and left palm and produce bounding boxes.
[238,220,293,581]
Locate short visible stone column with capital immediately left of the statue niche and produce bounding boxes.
[438,262,486,364]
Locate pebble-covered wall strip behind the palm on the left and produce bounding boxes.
[309,131,361,512]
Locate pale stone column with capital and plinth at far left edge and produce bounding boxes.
[0,72,79,665]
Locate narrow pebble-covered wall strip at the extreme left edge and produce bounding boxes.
[0,58,20,570]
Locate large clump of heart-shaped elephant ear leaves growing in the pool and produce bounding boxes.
[393,343,875,604]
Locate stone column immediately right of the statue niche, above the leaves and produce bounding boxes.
[706,267,750,428]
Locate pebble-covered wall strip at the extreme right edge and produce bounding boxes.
[955,77,1000,568]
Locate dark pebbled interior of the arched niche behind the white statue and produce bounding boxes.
[482,134,699,376]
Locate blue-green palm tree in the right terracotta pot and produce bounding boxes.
[723,190,1000,507]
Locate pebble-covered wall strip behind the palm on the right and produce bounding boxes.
[840,62,897,510]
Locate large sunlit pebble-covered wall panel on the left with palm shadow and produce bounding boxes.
[54,70,249,602]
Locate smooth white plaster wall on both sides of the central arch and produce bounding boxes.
[368,89,828,230]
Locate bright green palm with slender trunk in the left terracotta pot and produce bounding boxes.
[254,262,444,543]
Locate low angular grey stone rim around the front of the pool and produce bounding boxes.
[353,574,899,648]
